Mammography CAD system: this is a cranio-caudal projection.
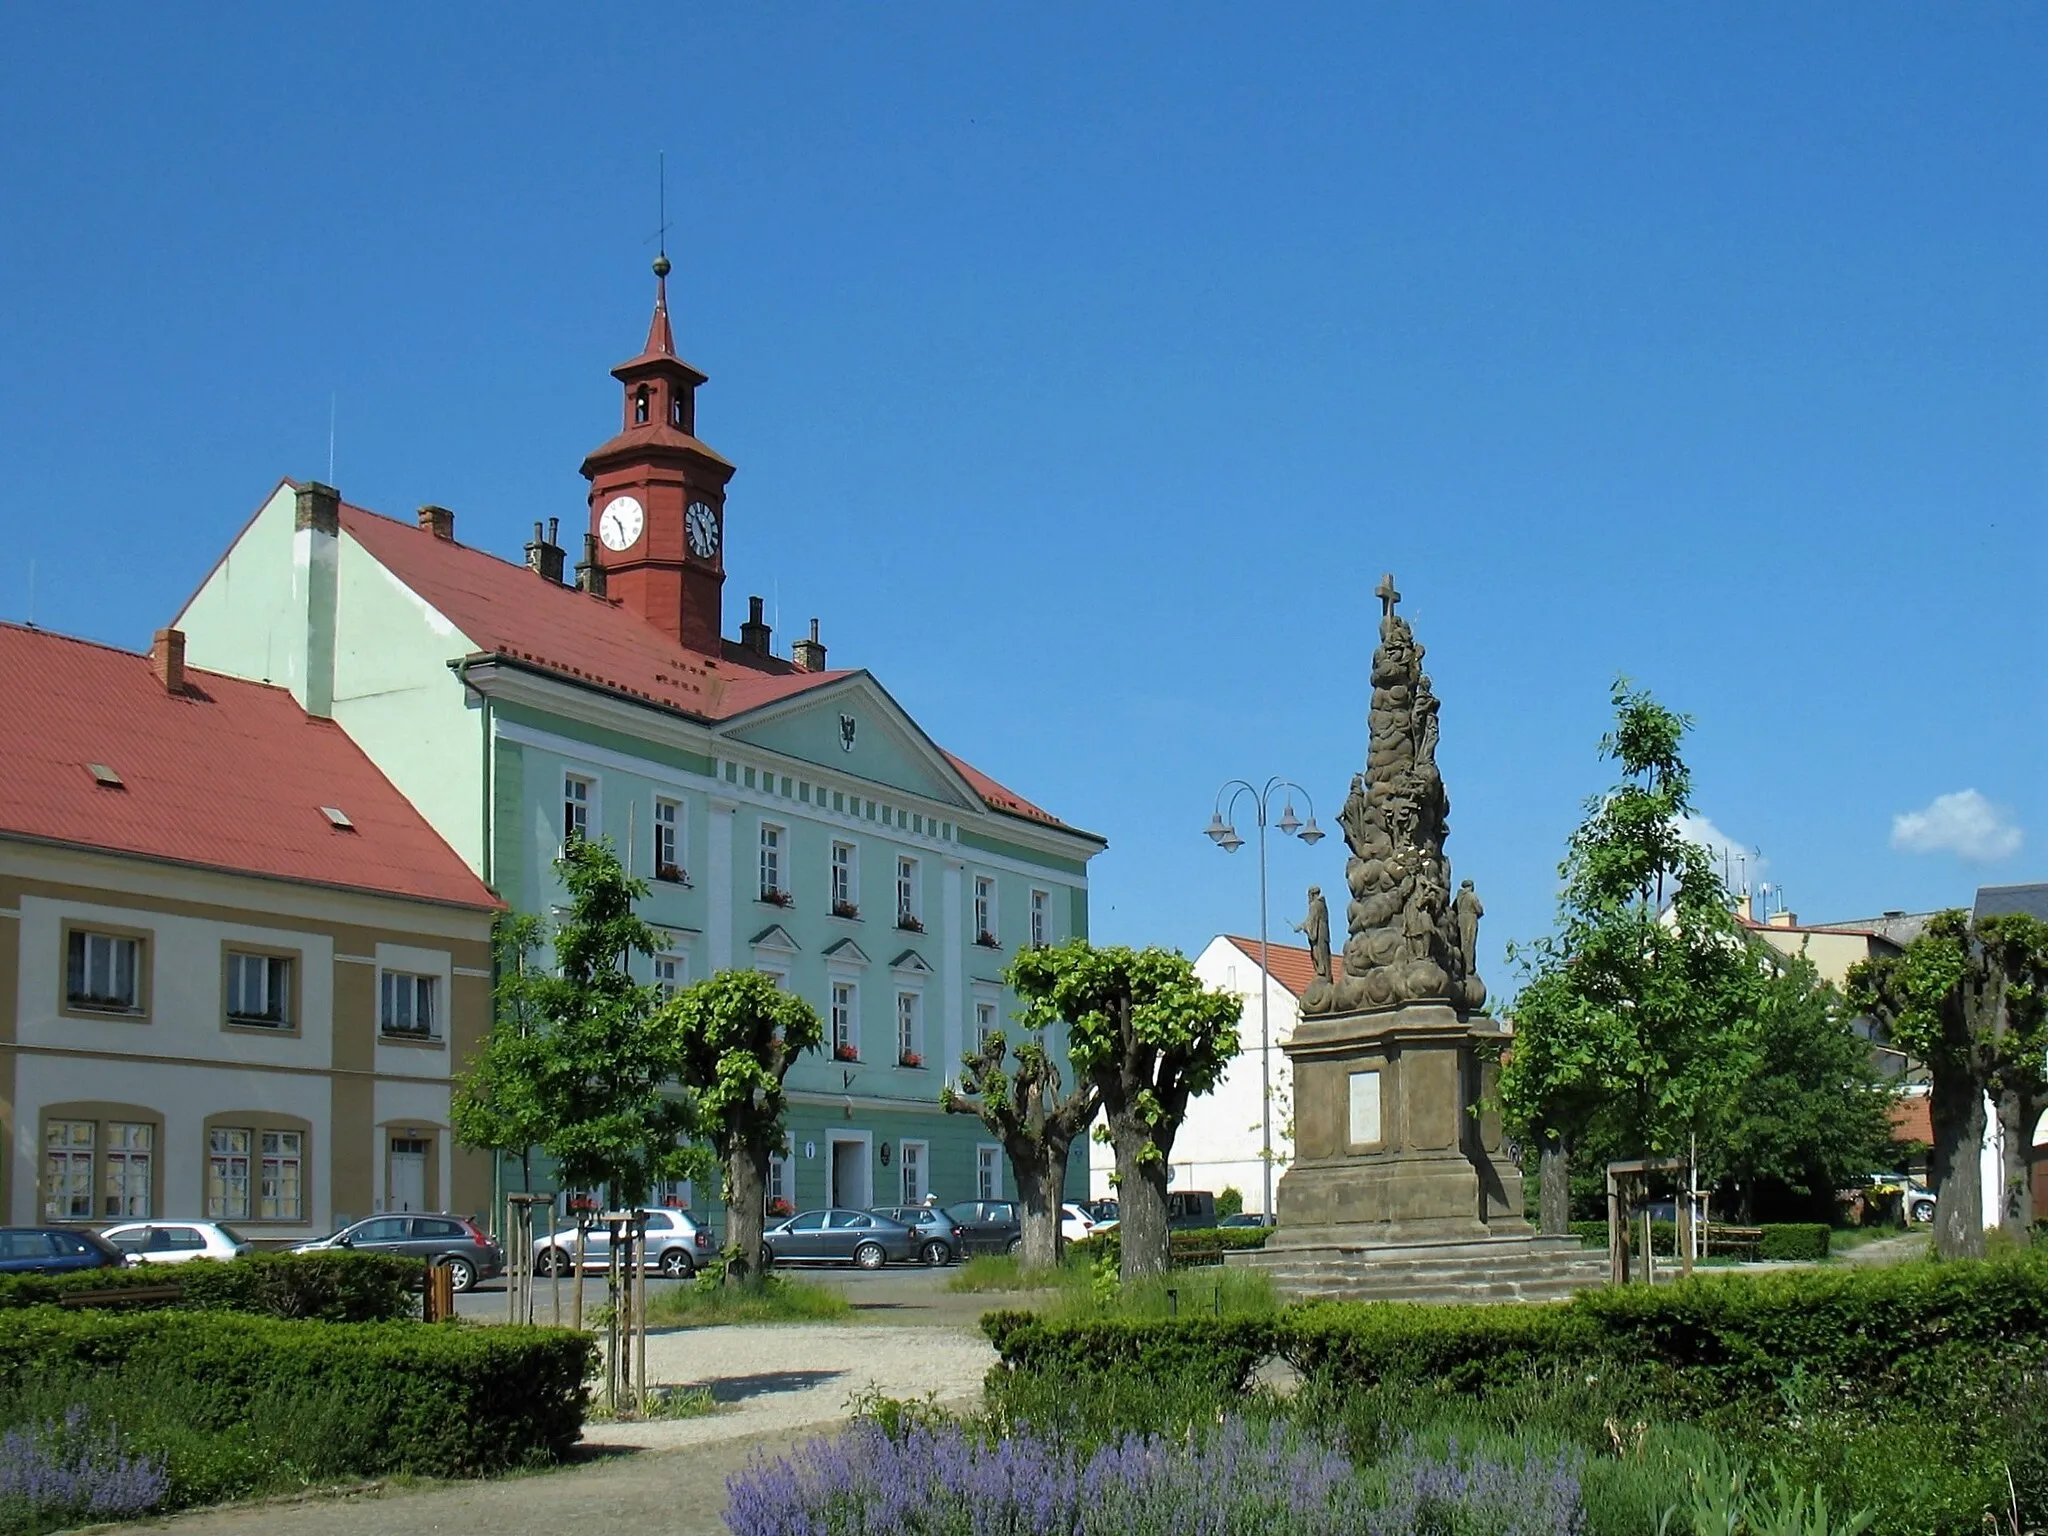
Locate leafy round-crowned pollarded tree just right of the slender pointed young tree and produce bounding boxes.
[662,971,825,1284]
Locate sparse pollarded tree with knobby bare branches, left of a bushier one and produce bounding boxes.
[938,1024,1102,1270]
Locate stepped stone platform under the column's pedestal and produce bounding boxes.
[1225,1229,1608,1303]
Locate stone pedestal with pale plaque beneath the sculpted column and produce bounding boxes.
[1274,1004,1530,1247]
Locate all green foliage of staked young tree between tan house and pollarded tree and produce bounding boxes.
[473,838,707,1204]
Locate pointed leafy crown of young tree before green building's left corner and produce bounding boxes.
[524,838,705,1206]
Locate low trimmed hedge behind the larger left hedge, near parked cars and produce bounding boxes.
[0,1251,426,1323]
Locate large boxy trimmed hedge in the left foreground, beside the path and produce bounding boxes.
[0,1307,596,1477]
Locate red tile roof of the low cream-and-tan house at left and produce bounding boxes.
[0,625,500,907]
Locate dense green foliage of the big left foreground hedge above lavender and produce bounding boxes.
[0,1307,594,1503]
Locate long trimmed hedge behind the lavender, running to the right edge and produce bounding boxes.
[983,1260,2048,1401]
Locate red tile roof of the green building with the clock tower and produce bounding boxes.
[327,504,1071,831]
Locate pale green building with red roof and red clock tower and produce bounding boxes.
[178,260,1104,1214]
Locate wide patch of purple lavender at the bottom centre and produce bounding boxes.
[725,1417,1585,1536]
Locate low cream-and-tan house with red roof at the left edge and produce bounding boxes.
[0,625,500,1241]
